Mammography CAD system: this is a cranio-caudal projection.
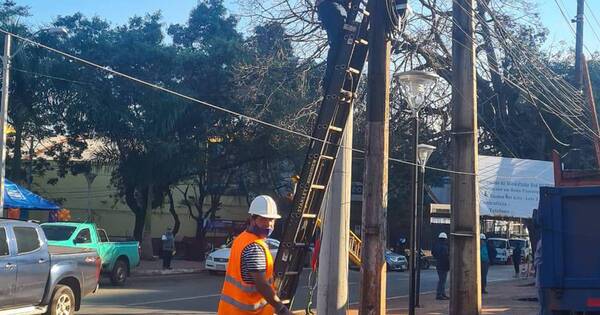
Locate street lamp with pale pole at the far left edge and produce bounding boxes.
[0,27,67,217]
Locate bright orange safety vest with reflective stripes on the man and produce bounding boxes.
[217,231,275,315]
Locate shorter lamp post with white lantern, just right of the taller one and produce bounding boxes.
[415,144,435,307]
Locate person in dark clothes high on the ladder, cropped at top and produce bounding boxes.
[316,0,350,92]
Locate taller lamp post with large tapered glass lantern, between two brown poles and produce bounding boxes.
[396,71,439,315]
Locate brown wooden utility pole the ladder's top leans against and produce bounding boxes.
[359,0,391,315]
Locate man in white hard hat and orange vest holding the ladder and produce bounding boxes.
[217,195,292,315]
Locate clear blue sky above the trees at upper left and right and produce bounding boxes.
[11,0,600,53]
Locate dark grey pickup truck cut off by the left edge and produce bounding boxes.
[0,219,101,315]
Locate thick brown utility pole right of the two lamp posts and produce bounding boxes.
[449,0,481,315]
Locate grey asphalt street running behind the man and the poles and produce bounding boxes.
[78,266,513,314]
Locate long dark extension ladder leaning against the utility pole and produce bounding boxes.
[275,0,369,307]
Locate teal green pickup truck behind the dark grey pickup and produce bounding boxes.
[42,222,140,286]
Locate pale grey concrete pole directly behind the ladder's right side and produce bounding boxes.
[317,108,353,315]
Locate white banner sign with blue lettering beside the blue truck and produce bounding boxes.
[479,155,554,218]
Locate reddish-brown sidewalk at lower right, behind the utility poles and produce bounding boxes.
[348,278,538,315]
